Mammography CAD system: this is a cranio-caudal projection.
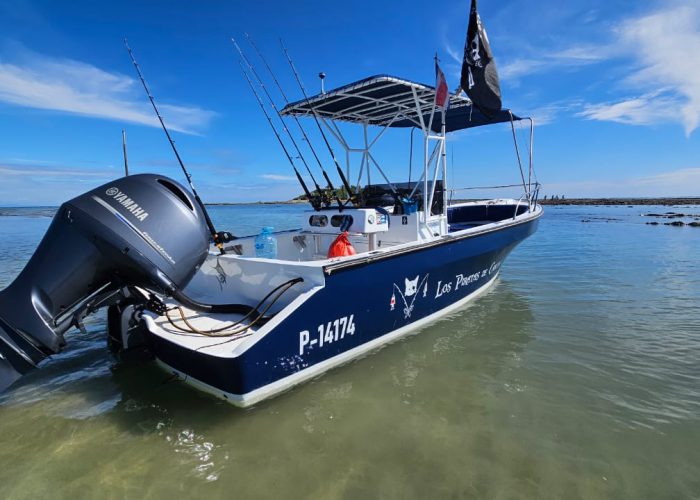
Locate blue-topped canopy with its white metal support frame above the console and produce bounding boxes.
[281,75,522,237]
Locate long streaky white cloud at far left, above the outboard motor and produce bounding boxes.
[0,50,216,133]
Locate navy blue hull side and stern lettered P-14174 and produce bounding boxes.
[151,217,538,402]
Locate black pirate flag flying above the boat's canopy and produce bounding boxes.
[460,0,501,118]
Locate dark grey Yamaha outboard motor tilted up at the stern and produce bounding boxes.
[0,174,210,391]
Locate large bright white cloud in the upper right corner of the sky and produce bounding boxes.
[581,2,700,135]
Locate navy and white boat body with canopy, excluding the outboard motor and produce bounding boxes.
[134,72,542,406]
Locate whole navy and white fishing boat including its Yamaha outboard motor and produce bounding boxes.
[0,2,543,407]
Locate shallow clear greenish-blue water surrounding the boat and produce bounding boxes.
[0,206,700,499]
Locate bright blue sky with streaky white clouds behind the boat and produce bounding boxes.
[0,0,700,206]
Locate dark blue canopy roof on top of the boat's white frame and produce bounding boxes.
[282,75,521,133]
